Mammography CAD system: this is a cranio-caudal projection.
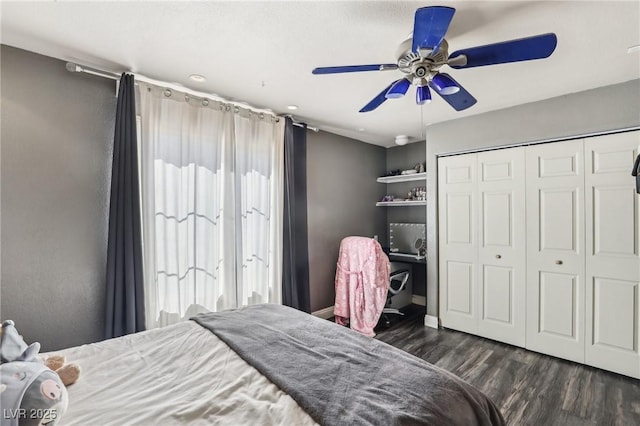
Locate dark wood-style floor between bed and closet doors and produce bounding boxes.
[376,306,640,426]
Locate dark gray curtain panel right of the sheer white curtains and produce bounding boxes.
[282,117,311,312]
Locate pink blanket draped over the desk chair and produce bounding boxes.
[333,237,391,337]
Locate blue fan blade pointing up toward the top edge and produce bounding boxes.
[411,6,456,53]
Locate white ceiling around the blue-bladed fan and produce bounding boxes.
[1,1,640,146]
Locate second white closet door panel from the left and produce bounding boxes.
[477,147,526,346]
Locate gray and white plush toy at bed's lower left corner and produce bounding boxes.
[0,321,68,426]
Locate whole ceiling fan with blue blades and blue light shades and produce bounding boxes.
[312,6,557,112]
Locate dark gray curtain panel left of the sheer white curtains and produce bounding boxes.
[105,74,145,338]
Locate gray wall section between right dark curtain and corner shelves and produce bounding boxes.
[307,131,386,311]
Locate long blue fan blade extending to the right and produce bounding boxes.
[449,33,558,68]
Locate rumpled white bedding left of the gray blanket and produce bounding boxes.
[50,321,316,426]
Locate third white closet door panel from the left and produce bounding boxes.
[526,140,585,362]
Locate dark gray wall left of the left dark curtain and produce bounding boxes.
[0,45,115,350]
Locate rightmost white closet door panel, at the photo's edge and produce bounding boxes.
[585,131,640,378]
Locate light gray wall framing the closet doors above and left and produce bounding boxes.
[427,80,640,315]
